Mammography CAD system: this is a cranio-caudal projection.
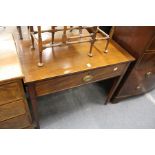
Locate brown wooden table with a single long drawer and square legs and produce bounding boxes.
[13,30,134,128]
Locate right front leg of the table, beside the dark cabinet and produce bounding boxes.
[105,63,130,104]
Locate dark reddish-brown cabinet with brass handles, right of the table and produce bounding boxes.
[112,26,155,102]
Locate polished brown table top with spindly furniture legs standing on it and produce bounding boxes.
[16,31,134,83]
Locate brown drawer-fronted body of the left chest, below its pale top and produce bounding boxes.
[0,80,31,129]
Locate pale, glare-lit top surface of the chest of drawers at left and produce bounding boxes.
[0,33,23,82]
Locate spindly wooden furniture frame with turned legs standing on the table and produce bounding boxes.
[29,26,110,67]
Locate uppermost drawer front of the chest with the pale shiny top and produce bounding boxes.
[0,81,22,105]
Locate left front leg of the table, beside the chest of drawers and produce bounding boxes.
[27,84,40,129]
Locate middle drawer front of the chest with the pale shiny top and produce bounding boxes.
[0,100,26,121]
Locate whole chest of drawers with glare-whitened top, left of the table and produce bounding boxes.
[0,34,32,129]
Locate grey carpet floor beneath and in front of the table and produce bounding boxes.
[38,84,155,129]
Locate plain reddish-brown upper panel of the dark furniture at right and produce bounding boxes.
[113,26,155,58]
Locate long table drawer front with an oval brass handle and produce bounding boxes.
[35,64,126,96]
